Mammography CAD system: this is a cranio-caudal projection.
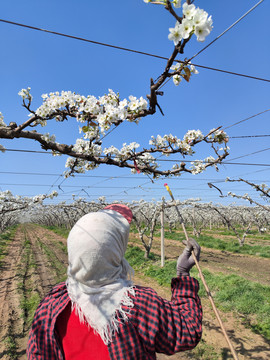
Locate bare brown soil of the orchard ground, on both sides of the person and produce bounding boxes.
[0,225,270,360]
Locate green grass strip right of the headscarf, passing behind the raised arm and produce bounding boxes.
[126,247,270,340]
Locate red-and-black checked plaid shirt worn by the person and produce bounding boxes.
[27,276,202,360]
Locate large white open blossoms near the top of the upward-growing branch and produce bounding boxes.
[168,2,213,45]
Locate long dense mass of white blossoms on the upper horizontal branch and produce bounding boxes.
[31,89,147,135]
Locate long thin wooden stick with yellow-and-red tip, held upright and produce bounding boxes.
[164,183,238,360]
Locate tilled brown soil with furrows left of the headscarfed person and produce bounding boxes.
[0,225,67,360]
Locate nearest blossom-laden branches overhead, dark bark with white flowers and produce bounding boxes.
[0,0,229,178]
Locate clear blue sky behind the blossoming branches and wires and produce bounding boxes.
[0,0,270,204]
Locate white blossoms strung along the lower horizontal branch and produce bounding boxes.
[61,126,228,177]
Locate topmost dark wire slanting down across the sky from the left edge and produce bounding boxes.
[0,19,270,82]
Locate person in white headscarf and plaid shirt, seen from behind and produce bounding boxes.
[27,204,202,360]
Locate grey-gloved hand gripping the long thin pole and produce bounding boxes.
[176,238,201,276]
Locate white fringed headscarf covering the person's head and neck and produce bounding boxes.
[67,210,134,344]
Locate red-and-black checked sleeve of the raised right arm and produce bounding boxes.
[132,276,202,355]
